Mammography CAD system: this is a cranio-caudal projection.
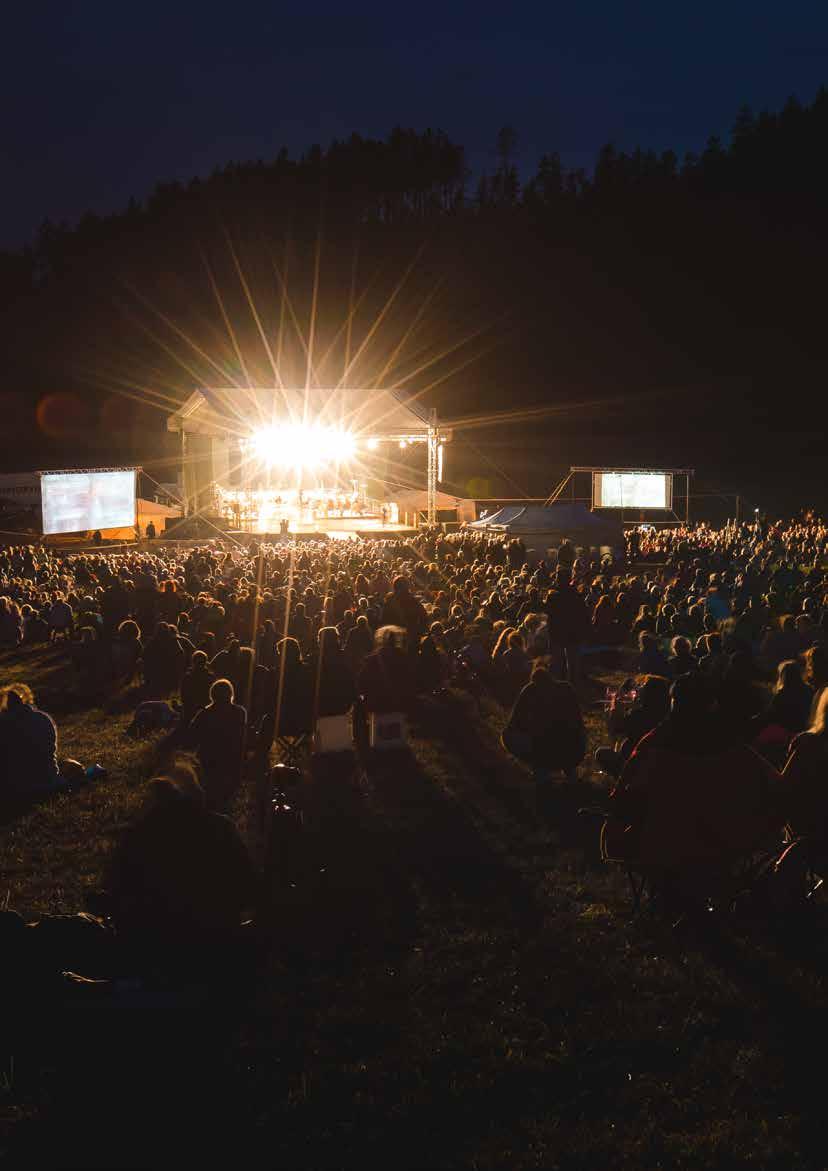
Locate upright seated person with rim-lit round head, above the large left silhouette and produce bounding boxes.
[189,679,247,809]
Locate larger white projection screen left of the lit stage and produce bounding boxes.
[40,468,136,536]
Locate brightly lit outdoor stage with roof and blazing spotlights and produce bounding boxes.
[167,385,451,535]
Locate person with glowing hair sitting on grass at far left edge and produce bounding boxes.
[0,683,84,802]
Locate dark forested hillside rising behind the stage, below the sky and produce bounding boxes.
[0,91,828,506]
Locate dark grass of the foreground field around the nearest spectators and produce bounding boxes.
[0,652,826,1169]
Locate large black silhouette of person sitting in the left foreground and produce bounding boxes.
[105,754,259,977]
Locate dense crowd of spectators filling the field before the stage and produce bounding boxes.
[0,516,828,932]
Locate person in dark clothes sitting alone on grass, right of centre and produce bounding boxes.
[501,666,587,781]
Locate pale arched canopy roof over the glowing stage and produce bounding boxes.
[166,386,429,438]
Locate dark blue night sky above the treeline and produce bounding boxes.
[6,0,828,247]
